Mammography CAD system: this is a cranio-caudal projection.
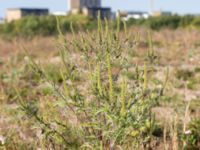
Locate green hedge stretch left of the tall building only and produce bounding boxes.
[0,15,95,37]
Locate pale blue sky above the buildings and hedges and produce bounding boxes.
[0,0,200,17]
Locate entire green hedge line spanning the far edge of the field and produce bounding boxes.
[0,15,200,37]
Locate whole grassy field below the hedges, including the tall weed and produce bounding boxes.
[0,27,200,150]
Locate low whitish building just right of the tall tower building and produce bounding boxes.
[116,11,149,21]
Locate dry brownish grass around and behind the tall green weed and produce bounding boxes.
[0,28,200,150]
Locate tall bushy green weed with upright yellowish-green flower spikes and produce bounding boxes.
[18,14,167,149]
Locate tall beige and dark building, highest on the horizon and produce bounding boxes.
[69,0,111,19]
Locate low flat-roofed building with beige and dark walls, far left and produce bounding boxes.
[6,8,49,22]
